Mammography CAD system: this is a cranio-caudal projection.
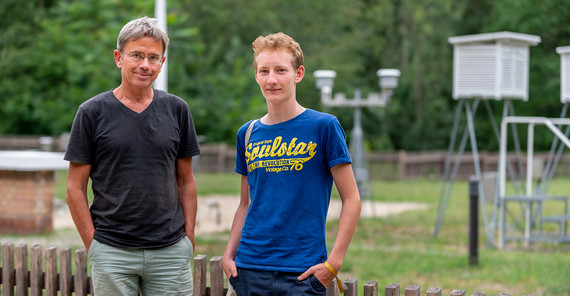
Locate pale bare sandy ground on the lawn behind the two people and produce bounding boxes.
[54,195,428,235]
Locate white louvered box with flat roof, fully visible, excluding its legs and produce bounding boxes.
[448,32,540,101]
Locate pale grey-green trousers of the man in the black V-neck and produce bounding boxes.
[89,236,194,296]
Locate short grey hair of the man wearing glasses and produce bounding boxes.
[117,16,168,54]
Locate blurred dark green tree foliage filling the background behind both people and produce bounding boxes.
[0,0,570,151]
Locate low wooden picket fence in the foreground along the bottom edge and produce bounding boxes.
[0,242,510,296]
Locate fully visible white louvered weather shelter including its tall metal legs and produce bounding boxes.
[434,31,541,244]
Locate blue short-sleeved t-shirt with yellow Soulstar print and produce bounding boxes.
[235,109,351,272]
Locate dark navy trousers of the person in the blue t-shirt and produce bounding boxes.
[229,267,327,296]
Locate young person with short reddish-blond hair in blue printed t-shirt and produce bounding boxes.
[223,33,360,296]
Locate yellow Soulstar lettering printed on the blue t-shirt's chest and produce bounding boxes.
[245,136,317,173]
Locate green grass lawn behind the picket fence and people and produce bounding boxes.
[11,172,570,295]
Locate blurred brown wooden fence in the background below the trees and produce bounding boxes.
[4,134,570,180]
